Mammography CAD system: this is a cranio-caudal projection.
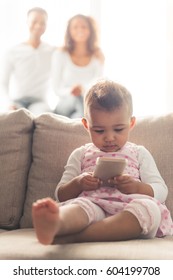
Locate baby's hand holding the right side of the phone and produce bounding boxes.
[109,174,141,194]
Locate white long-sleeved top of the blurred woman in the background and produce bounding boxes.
[52,50,104,97]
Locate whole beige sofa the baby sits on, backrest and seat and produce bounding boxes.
[0,109,173,260]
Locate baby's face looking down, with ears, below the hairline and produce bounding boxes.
[84,106,135,152]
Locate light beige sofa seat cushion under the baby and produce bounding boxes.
[0,229,173,260]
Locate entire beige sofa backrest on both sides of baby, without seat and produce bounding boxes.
[0,109,173,229]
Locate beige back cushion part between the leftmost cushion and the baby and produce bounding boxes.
[20,113,89,228]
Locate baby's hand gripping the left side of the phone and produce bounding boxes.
[78,172,102,191]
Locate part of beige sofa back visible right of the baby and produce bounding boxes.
[130,113,173,218]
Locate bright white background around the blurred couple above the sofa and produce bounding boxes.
[0,0,173,116]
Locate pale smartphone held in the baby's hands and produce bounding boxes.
[94,157,127,181]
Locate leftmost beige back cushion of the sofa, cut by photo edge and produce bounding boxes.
[0,109,34,229]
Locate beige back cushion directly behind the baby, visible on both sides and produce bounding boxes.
[20,113,173,227]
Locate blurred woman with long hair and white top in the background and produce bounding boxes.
[52,14,104,118]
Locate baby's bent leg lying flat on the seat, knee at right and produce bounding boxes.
[58,199,161,243]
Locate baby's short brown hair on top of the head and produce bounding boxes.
[84,80,133,116]
